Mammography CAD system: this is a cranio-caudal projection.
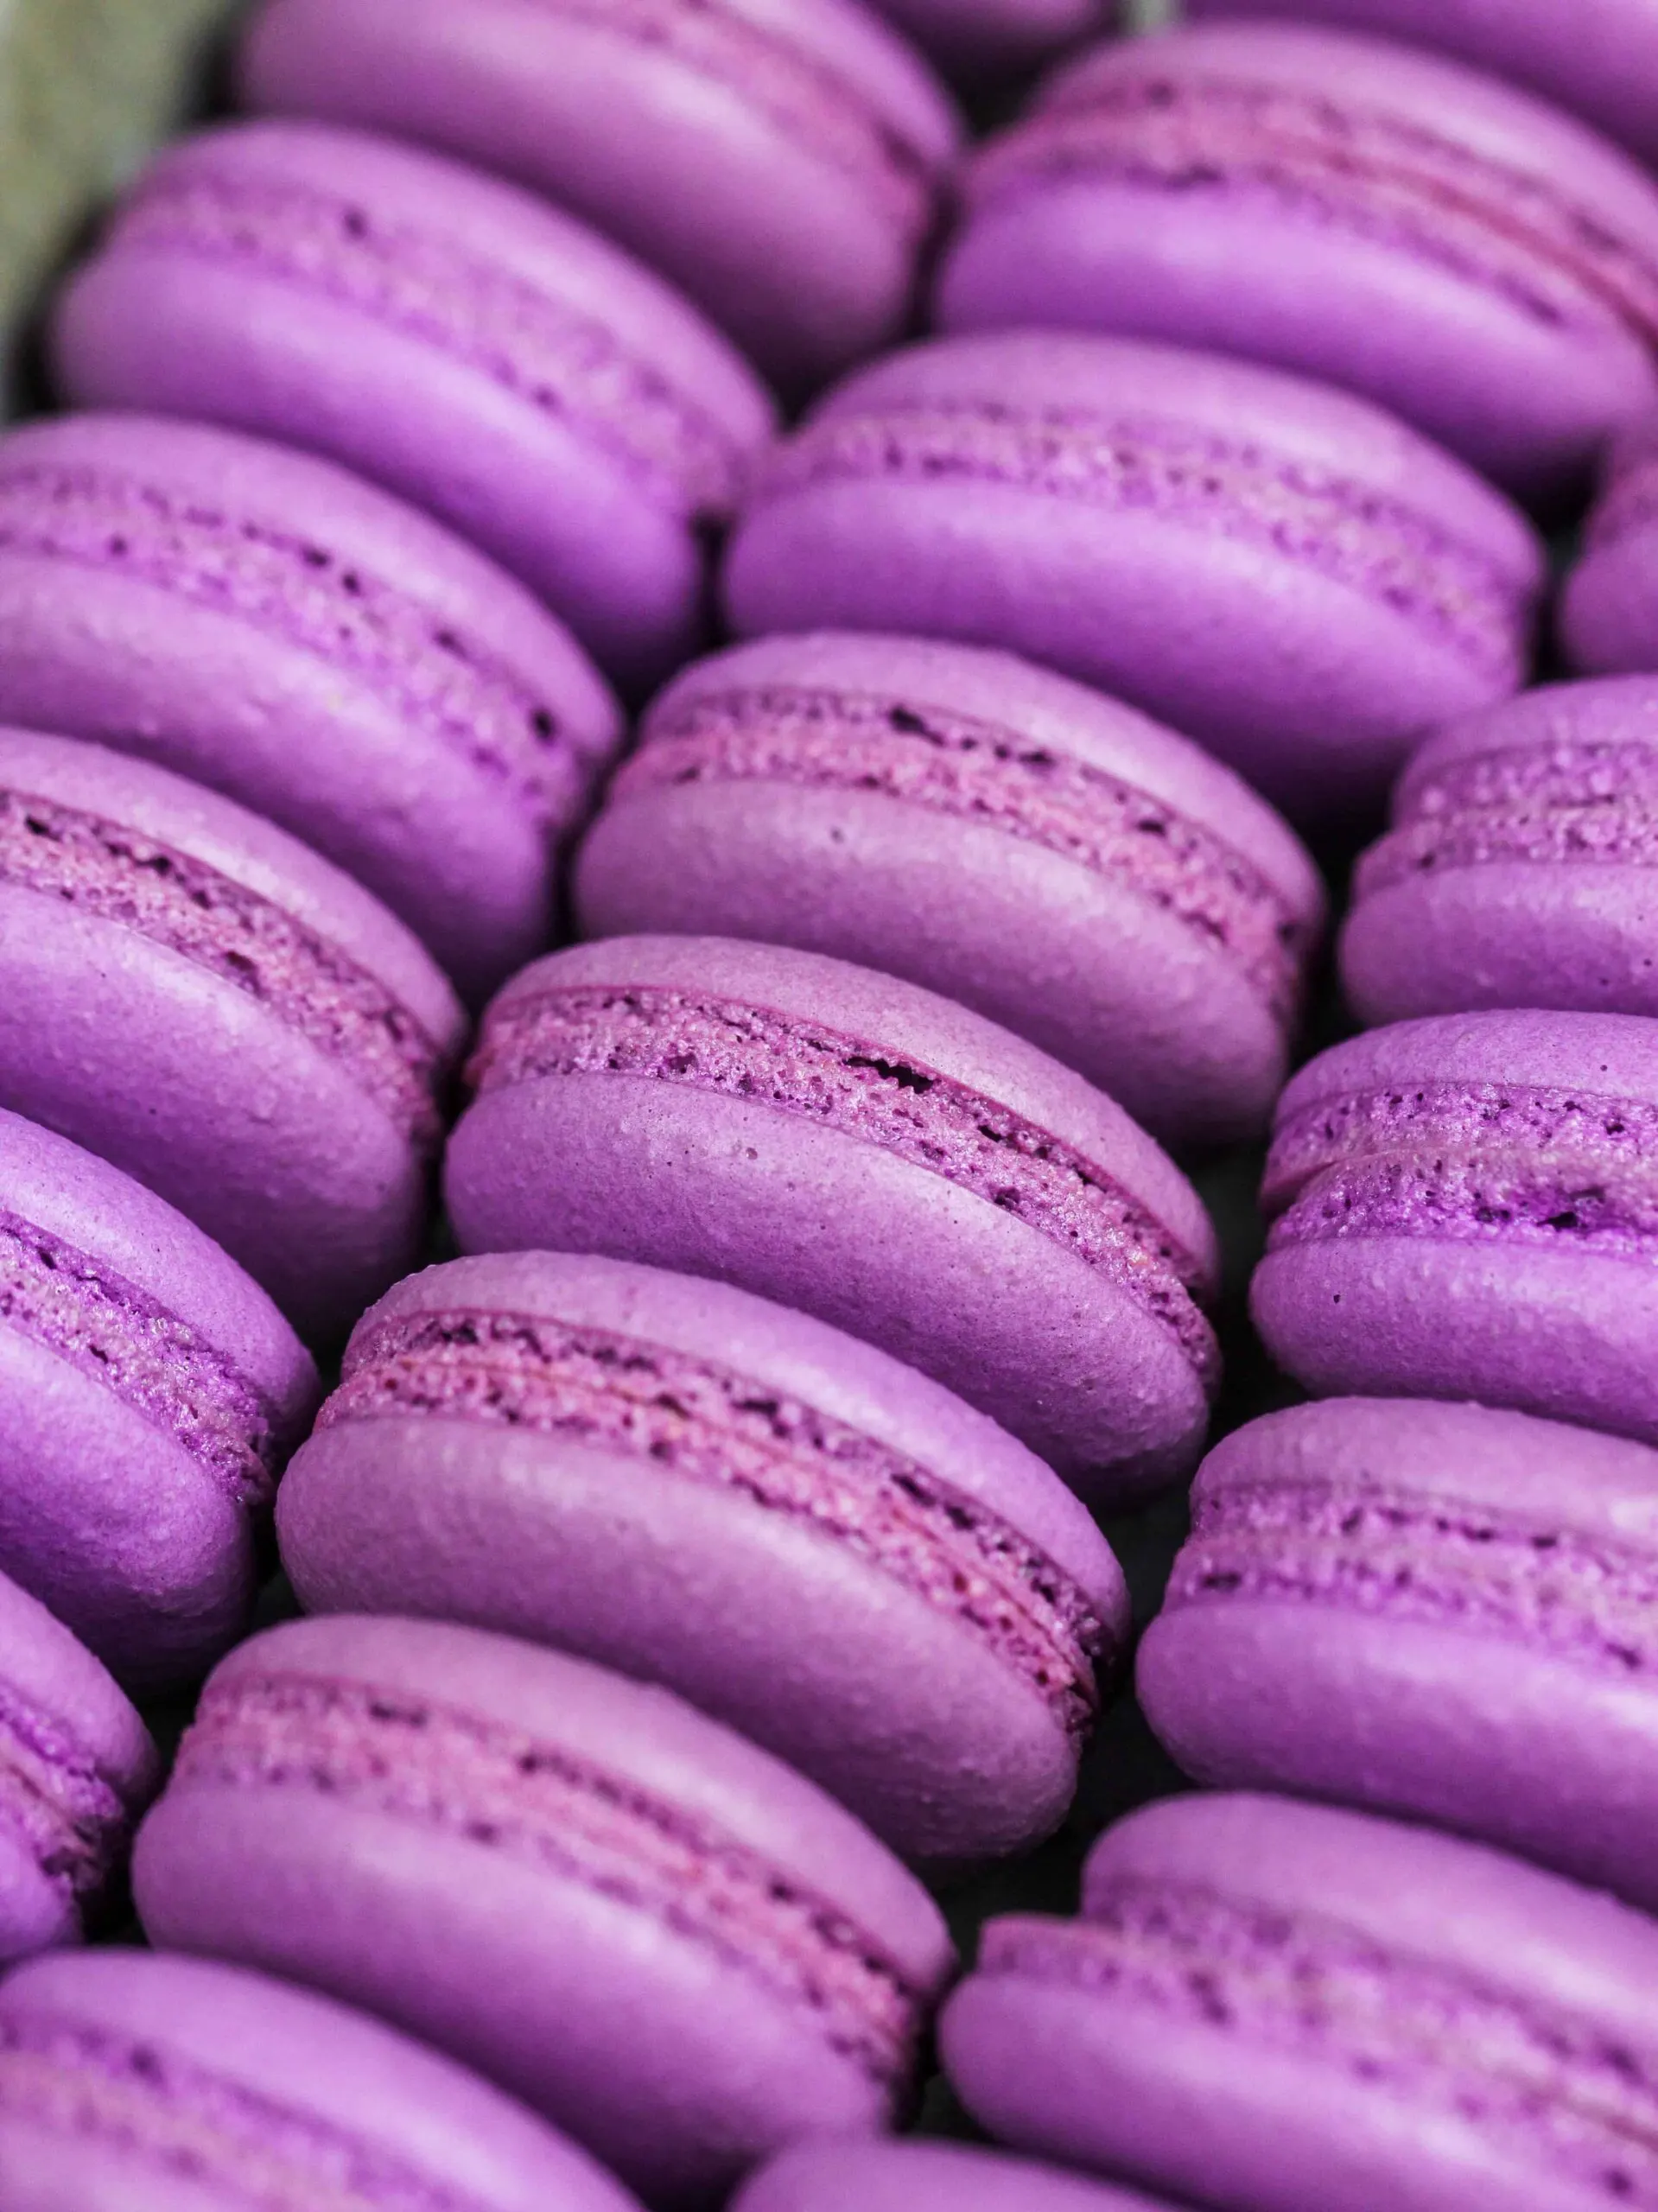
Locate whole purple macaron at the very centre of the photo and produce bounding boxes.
[447,938,1218,1500]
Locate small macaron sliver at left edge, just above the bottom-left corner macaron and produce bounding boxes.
[0,1575,162,1973]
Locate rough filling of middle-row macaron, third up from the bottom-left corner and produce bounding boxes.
[318,1312,1108,1738]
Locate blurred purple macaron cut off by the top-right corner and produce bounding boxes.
[1185,0,1658,162]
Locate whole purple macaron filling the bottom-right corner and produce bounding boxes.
[942,1796,1658,2212]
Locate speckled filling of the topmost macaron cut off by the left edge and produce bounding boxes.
[0,447,596,823]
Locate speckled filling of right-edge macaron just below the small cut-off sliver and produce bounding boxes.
[1355,741,1658,898]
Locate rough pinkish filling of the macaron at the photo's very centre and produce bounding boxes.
[468,984,1218,1382]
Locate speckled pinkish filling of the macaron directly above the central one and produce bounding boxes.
[627,683,1311,1024]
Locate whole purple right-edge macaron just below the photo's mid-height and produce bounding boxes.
[1251,1011,1658,1442]
